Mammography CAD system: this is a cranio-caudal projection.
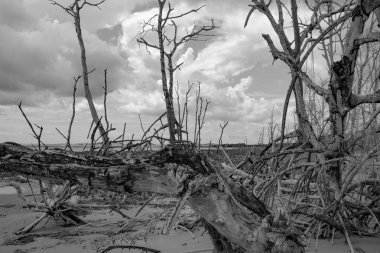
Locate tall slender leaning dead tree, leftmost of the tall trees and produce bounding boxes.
[49,0,109,143]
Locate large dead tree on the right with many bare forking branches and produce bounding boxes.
[245,0,380,247]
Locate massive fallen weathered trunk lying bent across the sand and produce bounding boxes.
[0,143,304,252]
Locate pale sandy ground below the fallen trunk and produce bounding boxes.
[0,185,380,253]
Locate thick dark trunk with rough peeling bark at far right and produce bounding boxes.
[324,1,375,189]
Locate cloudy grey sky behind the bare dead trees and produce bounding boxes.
[0,0,306,144]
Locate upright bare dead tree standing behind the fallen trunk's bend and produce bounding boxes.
[137,0,217,143]
